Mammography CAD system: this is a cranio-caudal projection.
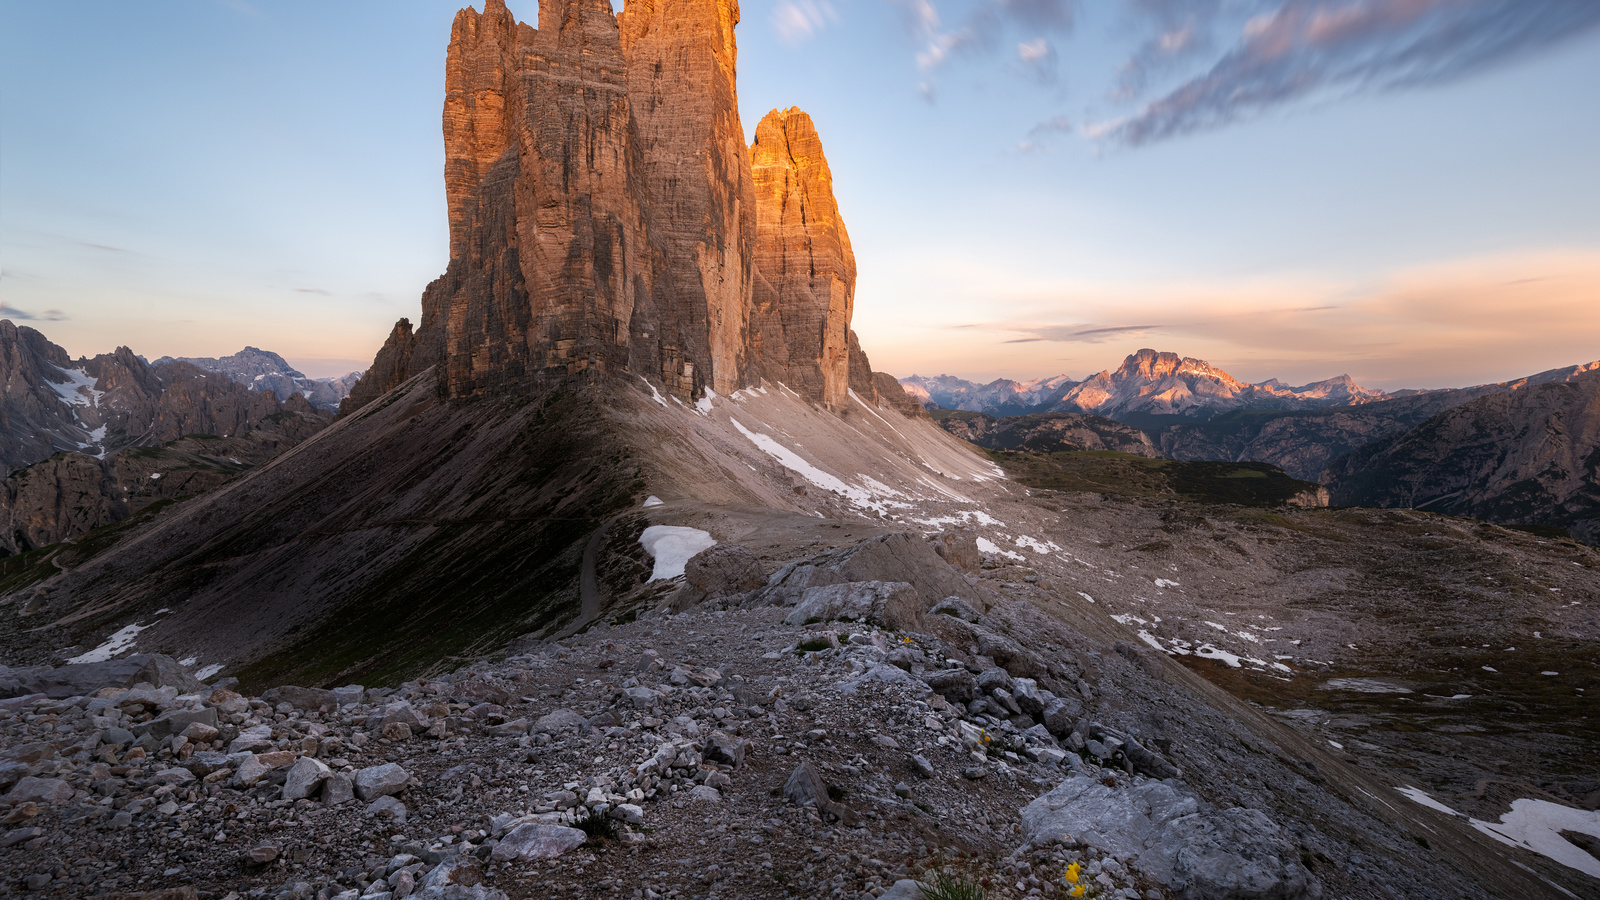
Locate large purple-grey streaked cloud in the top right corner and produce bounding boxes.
[1085,0,1600,146]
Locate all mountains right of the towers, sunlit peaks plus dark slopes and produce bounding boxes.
[902,351,1600,543]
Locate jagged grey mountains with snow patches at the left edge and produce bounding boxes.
[0,320,330,556]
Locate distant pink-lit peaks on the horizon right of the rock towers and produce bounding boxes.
[901,349,1389,426]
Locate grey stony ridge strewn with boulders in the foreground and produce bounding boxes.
[0,548,1350,900]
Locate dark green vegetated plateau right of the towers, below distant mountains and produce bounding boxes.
[989,450,1320,508]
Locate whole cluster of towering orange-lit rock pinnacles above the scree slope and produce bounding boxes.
[342,0,918,415]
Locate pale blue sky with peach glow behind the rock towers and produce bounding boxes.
[0,0,1600,388]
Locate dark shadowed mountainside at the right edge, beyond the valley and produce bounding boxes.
[1328,366,1600,536]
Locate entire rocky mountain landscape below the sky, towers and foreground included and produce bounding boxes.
[0,0,1600,900]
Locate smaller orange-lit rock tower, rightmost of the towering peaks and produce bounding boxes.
[750,109,870,408]
